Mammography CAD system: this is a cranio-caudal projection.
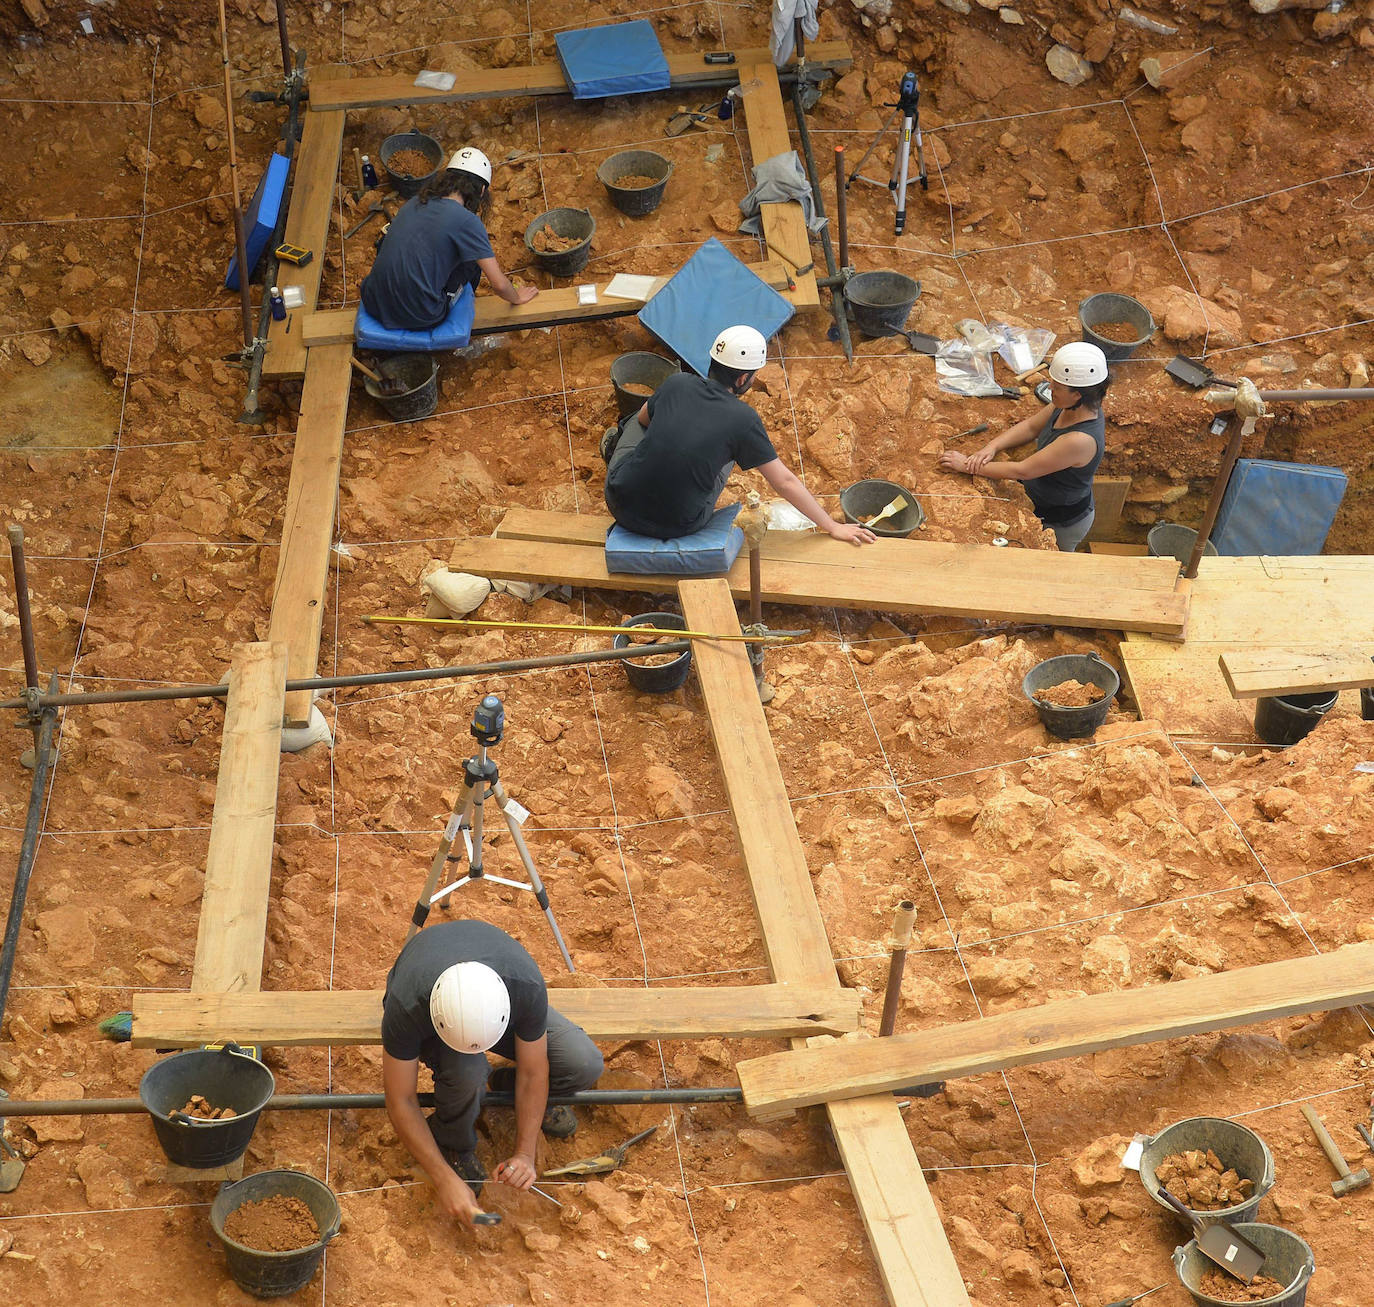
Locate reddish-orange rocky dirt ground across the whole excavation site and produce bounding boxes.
[0,0,1374,1307]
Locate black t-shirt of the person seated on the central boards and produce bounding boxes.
[606,372,778,540]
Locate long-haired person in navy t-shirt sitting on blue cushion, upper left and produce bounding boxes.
[363,146,539,331]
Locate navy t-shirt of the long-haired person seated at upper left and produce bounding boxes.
[363,197,493,331]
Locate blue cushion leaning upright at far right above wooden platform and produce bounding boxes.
[1212,459,1345,557]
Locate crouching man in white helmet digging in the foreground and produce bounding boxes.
[382,921,602,1225]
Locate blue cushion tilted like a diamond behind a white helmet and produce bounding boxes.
[639,236,796,377]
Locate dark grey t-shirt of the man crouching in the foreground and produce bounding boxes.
[382,921,548,1062]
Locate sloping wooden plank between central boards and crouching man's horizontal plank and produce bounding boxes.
[677,580,837,984]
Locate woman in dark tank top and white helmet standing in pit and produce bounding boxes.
[940,341,1112,552]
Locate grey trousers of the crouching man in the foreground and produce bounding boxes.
[420,1007,605,1153]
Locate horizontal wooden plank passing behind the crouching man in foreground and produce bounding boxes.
[133,978,860,1049]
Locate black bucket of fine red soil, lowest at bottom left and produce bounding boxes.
[210,1171,344,1297]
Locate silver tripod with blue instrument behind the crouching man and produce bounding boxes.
[405,694,577,972]
